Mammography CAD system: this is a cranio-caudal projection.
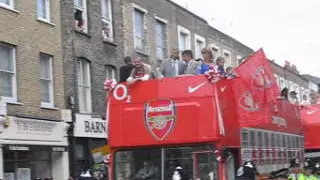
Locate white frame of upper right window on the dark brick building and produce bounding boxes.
[101,0,114,42]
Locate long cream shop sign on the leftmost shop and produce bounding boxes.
[0,117,66,144]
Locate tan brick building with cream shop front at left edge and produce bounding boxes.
[0,0,69,179]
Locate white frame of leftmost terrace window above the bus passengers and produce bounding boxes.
[132,3,148,53]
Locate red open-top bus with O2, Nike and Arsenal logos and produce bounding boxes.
[107,50,303,180]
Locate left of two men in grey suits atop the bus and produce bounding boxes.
[160,49,186,78]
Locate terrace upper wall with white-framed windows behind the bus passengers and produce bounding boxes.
[122,0,252,67]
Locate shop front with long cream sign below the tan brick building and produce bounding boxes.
[0,116,69,180]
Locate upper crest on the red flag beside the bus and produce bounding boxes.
[252,67,272,89]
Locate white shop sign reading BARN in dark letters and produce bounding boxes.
[74,114,107,138]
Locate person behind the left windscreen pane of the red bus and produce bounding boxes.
[134,161,160,180]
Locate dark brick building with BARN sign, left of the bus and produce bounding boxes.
[61,0,123,176]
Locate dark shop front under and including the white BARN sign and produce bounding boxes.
[70,114,107,176]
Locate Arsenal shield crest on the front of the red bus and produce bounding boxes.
[145,100,176,141]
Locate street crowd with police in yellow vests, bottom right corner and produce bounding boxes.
[236,159,320,180]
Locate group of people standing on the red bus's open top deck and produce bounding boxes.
[120,48,236,84]
